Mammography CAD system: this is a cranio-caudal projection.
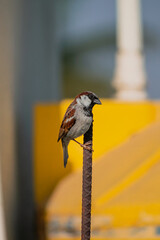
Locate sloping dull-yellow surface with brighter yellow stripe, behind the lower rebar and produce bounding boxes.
[45,122,160,230]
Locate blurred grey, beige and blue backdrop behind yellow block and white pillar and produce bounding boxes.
[0,0,160,240]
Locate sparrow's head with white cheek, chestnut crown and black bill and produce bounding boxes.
[76,91,102,109]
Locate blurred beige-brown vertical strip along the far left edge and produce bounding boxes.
[0,1,17,240]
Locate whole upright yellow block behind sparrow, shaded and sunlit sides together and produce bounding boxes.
[33,99,160,205]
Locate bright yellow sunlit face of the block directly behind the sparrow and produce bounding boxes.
[61,100,160,170]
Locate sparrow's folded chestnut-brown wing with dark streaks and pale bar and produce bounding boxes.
[58,104,76,141]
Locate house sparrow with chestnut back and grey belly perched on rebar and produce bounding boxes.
[58,91,101,167]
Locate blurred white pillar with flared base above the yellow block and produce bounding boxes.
[113,0,147,101]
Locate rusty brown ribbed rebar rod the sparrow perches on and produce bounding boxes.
[81,123,93,240]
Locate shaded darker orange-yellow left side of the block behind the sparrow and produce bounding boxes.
[34,104,69,207]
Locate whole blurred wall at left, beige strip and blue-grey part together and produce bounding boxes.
[0,0,61,240]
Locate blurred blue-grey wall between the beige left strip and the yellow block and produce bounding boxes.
[15,0,61,240]
